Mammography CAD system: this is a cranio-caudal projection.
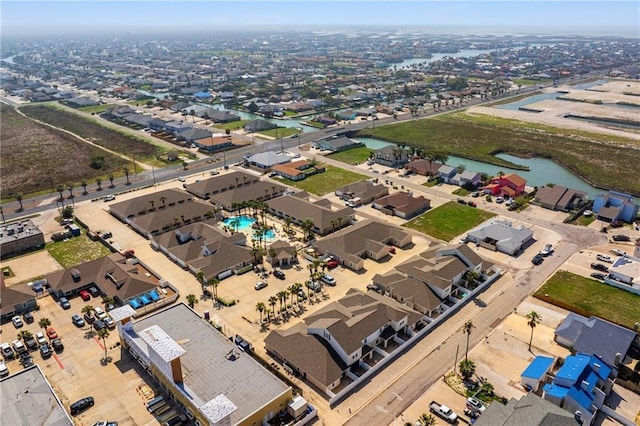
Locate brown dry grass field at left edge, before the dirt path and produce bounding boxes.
[0,104,132,202]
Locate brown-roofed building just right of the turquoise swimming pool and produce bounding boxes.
[267,191,355,235]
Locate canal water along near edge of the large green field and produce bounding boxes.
[356,138,640,203]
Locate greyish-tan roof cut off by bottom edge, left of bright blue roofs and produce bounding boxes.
[474,392,580,426]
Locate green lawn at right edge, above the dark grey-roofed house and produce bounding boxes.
[534,271,640,329]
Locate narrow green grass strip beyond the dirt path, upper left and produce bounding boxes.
[20,105,162,162]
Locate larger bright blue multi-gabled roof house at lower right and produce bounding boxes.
[542,353,613,425]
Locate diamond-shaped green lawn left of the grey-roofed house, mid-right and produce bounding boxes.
[403,201,495,241]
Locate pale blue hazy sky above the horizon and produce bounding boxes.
[0,0,640,38]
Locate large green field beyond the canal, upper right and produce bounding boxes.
[357,112,640,194]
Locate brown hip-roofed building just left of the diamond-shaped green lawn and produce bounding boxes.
[314,220,412,271]
